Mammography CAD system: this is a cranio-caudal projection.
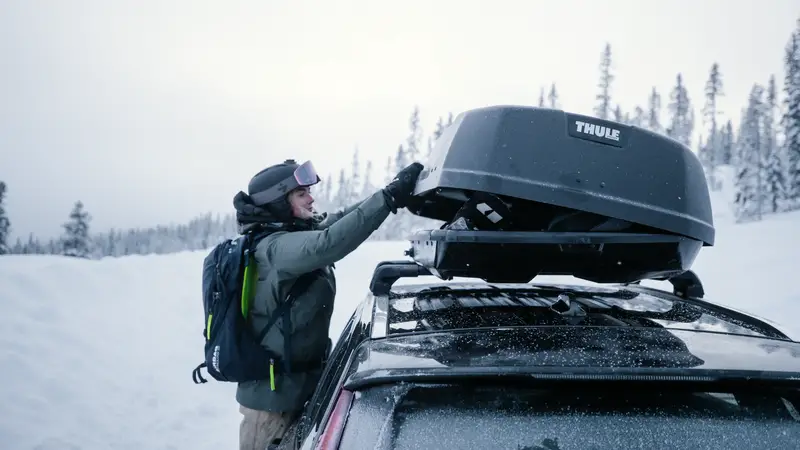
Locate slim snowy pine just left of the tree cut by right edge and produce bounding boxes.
[762,75,786,213]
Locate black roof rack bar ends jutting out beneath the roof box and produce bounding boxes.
[369,260,705,299]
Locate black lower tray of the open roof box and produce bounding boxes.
[407,230,703,283]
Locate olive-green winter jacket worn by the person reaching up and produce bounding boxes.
[236,191,390,412]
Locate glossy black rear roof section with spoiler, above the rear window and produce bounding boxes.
[345,326,800,385]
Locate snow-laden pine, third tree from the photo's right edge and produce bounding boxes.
[734,84,764,222]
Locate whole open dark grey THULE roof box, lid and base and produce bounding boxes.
[410,106,714,282]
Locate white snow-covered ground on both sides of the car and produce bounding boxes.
[0,199,800,450]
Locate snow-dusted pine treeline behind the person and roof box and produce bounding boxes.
[0,19,800,258]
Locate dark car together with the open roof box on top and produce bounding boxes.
[279,106,800,450]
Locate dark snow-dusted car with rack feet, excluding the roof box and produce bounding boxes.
[281,261,800,450]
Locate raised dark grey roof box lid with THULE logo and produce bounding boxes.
[412,106,715,246]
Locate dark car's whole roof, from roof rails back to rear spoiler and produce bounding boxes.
[346,281,800,386]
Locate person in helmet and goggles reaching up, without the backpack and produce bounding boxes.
[234,160,423,450]
